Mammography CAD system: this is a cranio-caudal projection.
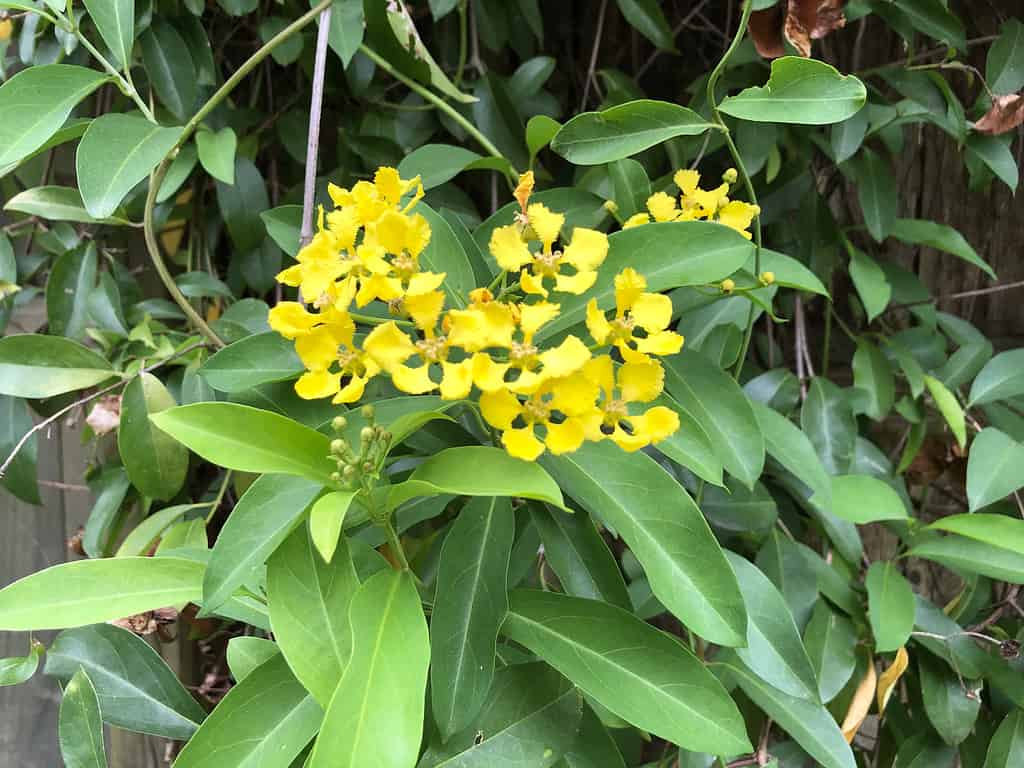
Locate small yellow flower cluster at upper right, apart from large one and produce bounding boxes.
[623,168,761,240]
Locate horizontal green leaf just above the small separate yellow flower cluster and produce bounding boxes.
[551,98,714,165]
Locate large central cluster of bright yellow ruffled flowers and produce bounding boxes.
[269,168,683,460]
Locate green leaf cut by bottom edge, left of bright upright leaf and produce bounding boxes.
[174,656,323,768]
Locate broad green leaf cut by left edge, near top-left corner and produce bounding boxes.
[0,65,111,167]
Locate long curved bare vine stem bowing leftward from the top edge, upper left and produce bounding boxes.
[142,0,334,347]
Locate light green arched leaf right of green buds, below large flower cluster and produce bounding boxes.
[385,438,564,509]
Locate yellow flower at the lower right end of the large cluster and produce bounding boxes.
[583,354,679,452]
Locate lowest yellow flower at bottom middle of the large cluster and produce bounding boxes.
[480,373,598,461]
